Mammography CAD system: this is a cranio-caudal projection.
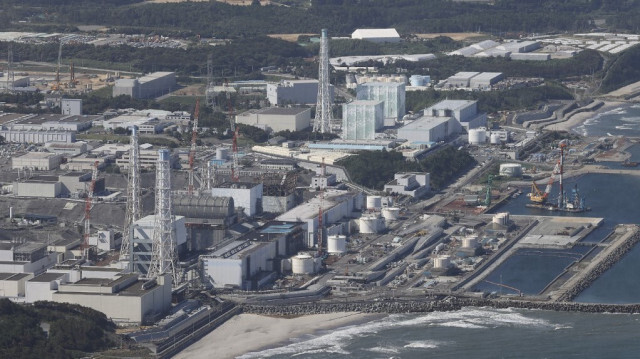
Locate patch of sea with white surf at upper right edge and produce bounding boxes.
[573,104,640,137]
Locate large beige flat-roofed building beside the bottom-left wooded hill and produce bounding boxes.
[52,273,171,324]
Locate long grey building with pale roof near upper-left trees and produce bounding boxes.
[113,72,176,98]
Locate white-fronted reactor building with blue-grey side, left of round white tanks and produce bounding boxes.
[200,222,305,290]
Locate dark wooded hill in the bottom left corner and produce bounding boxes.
[0,299,116,359]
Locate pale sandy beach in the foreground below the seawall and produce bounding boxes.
[174,313,380,359]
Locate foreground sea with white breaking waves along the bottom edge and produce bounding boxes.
[238,308,640,359]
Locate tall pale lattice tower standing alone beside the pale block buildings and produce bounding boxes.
[313,29,332,133]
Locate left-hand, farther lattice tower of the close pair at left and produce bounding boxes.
[120,126,142,260]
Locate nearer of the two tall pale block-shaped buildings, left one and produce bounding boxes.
[342,100,384,140]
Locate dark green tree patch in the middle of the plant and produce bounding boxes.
[337,146,476,190]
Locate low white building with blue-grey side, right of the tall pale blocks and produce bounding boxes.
[397,116,462,142]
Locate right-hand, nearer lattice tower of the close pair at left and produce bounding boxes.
[147,149,180,286]
